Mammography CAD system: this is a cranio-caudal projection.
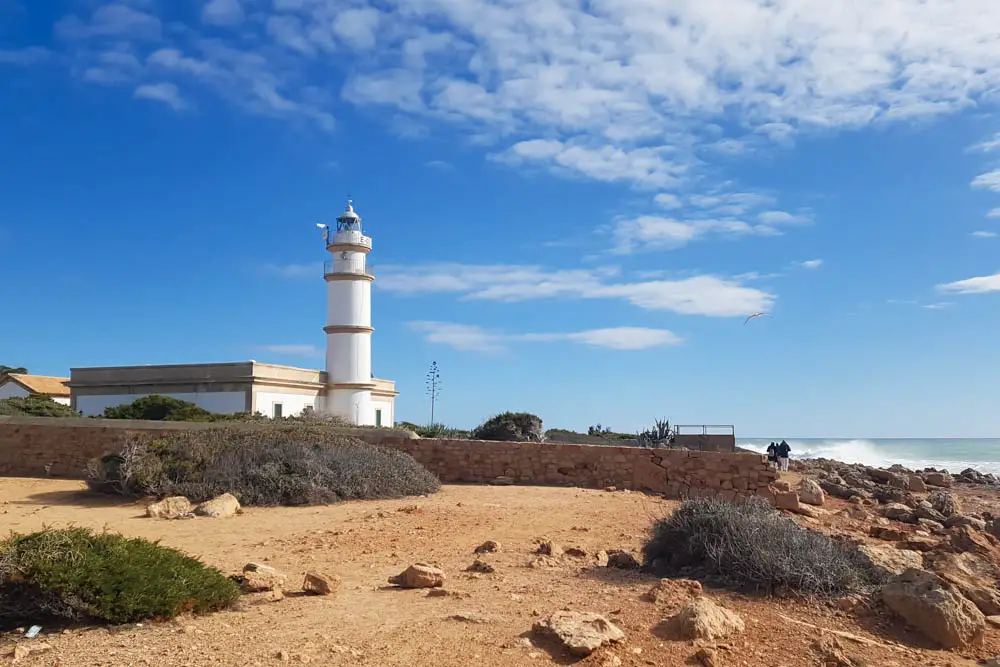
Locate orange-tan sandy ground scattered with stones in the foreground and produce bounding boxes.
[0,478,1000,667]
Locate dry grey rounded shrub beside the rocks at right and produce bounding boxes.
[643,498,885,596]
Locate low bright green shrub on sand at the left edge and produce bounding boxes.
[0,528,239,628]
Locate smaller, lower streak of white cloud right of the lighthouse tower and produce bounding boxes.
[409,321,683,352]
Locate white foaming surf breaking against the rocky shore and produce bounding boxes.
[737,439,1000,474]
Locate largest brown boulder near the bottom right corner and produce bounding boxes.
[882,569,986,649]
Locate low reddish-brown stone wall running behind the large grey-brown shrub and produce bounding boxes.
[0,417,776,498]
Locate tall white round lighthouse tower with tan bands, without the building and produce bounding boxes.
[320,199,375,425]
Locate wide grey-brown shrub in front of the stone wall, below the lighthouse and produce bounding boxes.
[88,424,441,505]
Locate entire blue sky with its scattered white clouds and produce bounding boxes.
[0,0,1000,437]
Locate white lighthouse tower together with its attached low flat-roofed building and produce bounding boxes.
[68,201,398,426]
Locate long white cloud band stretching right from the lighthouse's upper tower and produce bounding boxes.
[376,264,775,317]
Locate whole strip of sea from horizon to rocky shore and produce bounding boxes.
[736,438,1000,475]
